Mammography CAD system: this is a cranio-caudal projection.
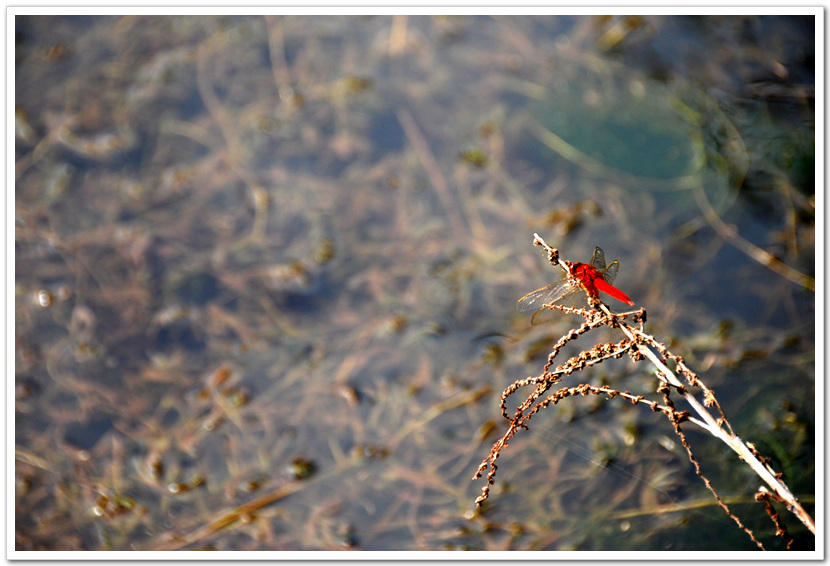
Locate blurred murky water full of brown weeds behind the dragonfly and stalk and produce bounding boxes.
[10,15,817,551]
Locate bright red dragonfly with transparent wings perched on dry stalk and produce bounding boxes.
[516,248,634,325]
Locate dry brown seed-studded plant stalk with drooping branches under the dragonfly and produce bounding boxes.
[473,234,815,550]
